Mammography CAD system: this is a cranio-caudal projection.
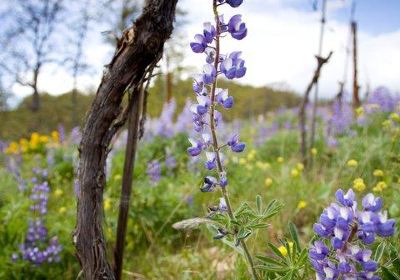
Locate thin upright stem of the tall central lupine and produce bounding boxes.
[210,0,258,280]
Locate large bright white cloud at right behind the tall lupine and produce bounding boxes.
[181,0,400,97]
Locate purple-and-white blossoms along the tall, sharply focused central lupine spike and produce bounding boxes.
[187,0,247,234]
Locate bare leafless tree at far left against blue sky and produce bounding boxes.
[0,0,65,111]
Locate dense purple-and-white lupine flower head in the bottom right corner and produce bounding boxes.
[309,189,395,280]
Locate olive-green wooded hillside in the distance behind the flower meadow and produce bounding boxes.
[0,77,299,140]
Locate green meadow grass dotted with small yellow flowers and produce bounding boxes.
[0,112,400,279]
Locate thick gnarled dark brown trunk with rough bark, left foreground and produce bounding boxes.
[73,0,178,279]
